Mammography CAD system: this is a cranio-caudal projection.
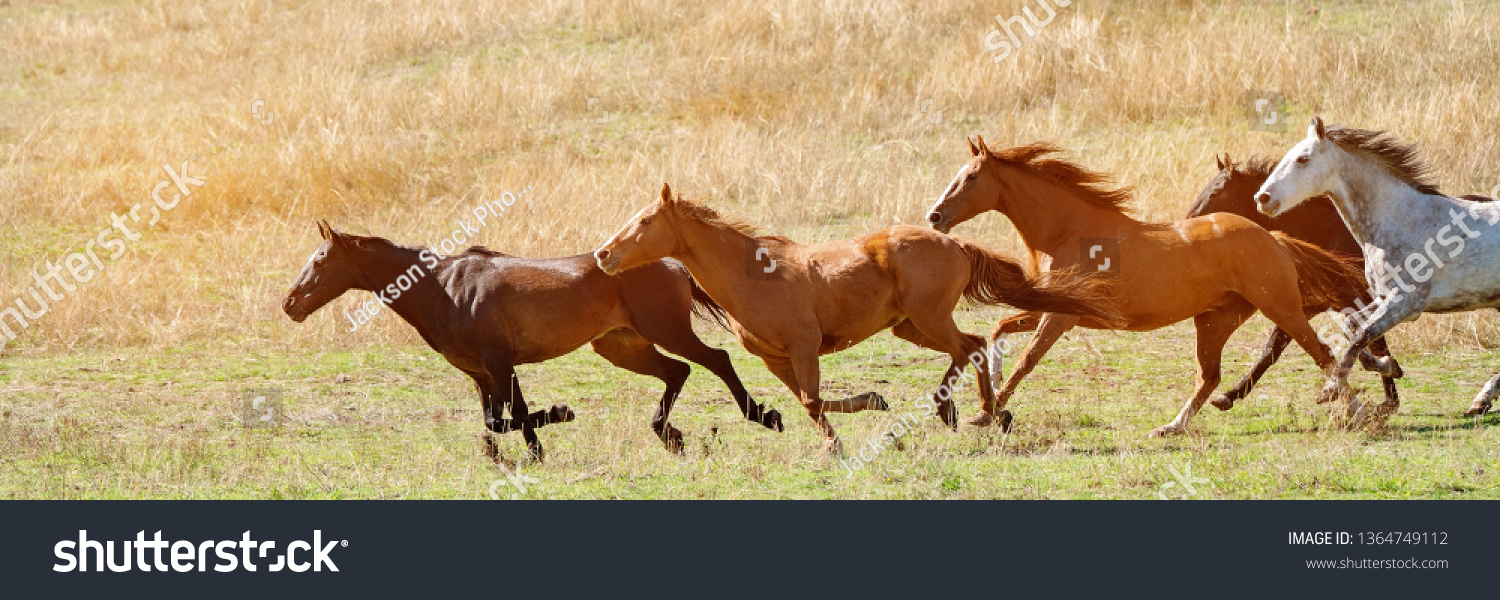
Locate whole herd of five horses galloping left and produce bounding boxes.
[282,119,1500,459]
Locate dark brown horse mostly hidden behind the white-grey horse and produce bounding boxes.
[1187,155,1401,420]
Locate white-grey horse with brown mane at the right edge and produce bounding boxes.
[1256,117,1500,416]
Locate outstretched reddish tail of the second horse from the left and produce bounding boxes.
[954,239,1125,326]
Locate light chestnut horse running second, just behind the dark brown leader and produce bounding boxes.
[594,186,1118,453]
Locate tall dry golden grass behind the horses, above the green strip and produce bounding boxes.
[0,0,1500,356]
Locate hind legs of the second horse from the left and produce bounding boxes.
[891,314,990,429]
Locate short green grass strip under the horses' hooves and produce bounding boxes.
[0,311,1500,498]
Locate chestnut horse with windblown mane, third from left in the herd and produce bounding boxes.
[927,138,1364,437]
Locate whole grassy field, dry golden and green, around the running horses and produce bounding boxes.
[0,0,1500,498]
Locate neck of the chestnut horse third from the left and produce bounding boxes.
[1002,173,1140,251]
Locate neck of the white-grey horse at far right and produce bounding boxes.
[1328,153,1446,246]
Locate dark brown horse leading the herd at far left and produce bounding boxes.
[282,222,782,459]
